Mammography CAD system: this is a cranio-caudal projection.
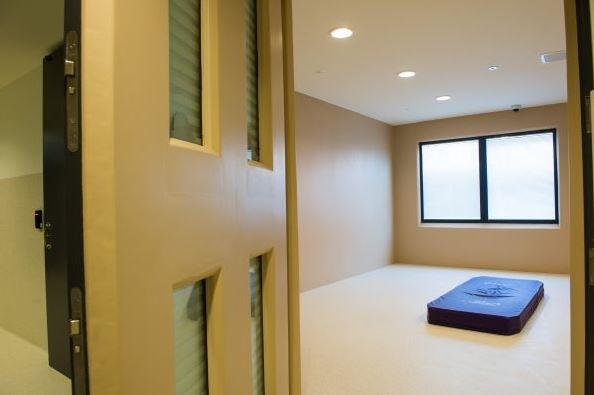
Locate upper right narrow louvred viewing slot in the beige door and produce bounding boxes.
[245,0,260,161]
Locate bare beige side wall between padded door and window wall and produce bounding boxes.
[295,93,392,291]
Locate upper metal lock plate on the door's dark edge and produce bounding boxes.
[64,31,80,152]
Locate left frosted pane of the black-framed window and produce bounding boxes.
[421,140,481,220]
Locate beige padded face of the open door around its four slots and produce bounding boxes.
[83,0,288,395]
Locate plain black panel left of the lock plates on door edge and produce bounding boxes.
[43,45,72,377]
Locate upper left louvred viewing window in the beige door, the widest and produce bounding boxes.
[169,0,203,145]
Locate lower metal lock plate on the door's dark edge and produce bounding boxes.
[69,287,88,395]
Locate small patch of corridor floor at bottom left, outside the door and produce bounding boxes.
[0,328,71,395]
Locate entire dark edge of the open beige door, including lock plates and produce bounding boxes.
[43,0,88,395]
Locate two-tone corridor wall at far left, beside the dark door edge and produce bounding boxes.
[0,67,47,348]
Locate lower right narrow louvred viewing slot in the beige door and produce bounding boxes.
[250,256,264,395]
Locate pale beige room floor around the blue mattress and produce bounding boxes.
[301,265,570,395]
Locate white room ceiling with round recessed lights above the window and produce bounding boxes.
[293,0,567,125]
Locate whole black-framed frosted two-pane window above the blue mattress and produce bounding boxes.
[419,130,559,223]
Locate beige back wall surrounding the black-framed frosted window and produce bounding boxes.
[392,104,569,273]
